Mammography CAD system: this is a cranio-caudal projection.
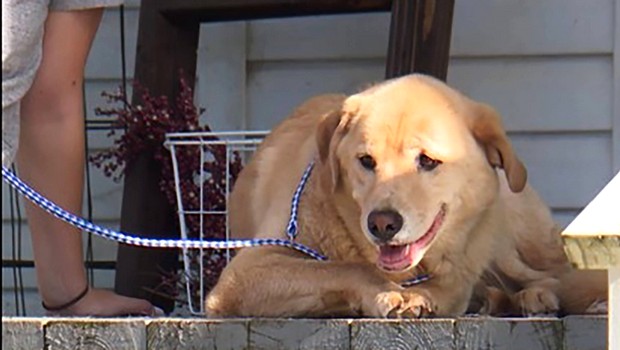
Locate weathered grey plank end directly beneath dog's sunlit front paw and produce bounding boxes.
[351,319,455,350]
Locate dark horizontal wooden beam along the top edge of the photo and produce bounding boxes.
[154,0,392,22]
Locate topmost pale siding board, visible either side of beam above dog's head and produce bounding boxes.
[248,0,614,61]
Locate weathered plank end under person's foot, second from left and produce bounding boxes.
[45,318,146,350]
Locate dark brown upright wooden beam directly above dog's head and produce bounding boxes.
[385,0,454,80]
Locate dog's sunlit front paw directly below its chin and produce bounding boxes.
[374,291,435,318]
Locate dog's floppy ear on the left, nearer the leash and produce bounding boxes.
[316,109,348,192]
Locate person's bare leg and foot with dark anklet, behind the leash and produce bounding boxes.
[17,8,154,316]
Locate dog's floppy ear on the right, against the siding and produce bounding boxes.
[468,103,527,192]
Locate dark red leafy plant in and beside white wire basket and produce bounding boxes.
[90,78,242,303]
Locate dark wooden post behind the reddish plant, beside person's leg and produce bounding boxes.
[115,1,200,312]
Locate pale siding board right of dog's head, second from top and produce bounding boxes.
[448,56,613,132]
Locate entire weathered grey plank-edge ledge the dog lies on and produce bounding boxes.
[2,316,607,350]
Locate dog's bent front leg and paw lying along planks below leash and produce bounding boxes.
[206,247,424,317]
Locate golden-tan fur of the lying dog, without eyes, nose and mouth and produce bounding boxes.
[206,75,605,317]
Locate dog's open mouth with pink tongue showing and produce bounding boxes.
[378,204,446,271]
